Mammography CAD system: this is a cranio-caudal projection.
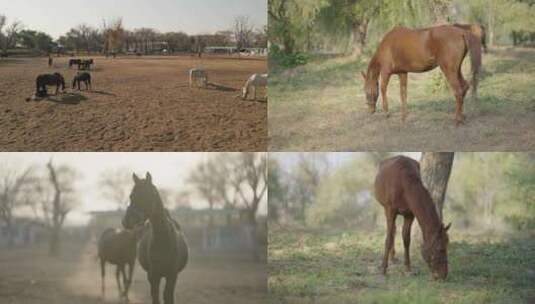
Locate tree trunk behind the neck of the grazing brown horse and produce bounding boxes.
[420,152,454,220]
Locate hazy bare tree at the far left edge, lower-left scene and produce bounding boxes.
[0,167,32,246]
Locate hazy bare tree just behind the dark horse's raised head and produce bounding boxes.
[98,168,132,209]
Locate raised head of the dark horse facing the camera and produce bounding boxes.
[123,172,159,229]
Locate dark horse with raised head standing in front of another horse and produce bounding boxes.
[123,173,188,304]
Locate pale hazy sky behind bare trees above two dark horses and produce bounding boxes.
[0,152,267,225]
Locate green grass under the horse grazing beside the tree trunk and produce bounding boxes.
[268,227,535,304]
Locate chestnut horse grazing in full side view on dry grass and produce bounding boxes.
[362,25,481,125]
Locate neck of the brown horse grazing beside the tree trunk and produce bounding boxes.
[404,182,442,241]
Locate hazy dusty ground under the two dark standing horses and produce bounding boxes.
[0,242,267,304]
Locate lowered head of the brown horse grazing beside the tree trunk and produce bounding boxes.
[422,223,451,280]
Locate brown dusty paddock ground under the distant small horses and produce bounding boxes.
[0,56,267,151]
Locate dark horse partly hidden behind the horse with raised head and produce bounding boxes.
[98,228,139,300]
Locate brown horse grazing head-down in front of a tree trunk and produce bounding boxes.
[375,156,451,279]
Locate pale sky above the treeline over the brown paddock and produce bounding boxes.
[0,0,267,39]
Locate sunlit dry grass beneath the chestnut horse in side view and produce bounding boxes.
[268,49,535,151]
